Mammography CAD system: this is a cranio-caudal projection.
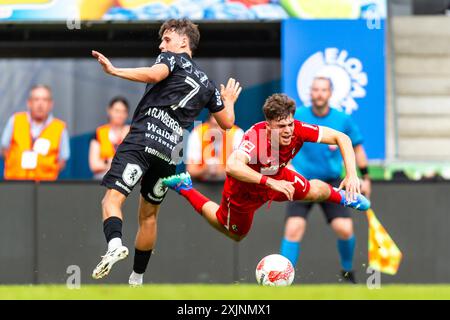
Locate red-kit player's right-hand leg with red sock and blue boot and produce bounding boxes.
[303,179,370,211]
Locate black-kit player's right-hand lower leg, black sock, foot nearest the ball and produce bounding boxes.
[128,196,160,286]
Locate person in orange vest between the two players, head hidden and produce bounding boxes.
[186,115,244,181]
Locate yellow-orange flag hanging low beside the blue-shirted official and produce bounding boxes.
[367,209,402,275]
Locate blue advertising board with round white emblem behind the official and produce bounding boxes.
[282,19,386,160]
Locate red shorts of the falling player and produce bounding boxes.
[216,168,310,236]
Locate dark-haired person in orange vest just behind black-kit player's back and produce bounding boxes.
[89,97,130,180]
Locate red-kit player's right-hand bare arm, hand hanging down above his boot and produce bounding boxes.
[320,126,361,200]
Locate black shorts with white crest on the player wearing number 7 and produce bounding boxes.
[102,141,176,205]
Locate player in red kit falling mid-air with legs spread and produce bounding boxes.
[163,94,370,241]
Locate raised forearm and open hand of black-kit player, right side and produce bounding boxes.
[213,78,242,130]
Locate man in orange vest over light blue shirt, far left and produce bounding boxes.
[1,85,70,181]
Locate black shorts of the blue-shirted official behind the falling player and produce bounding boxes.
[286,180,351,223]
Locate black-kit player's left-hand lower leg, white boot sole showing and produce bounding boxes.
[92,189,128,279]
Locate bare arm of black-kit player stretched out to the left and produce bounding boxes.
[92,50,169,83]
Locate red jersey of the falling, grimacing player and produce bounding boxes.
[238,120,321,176]
